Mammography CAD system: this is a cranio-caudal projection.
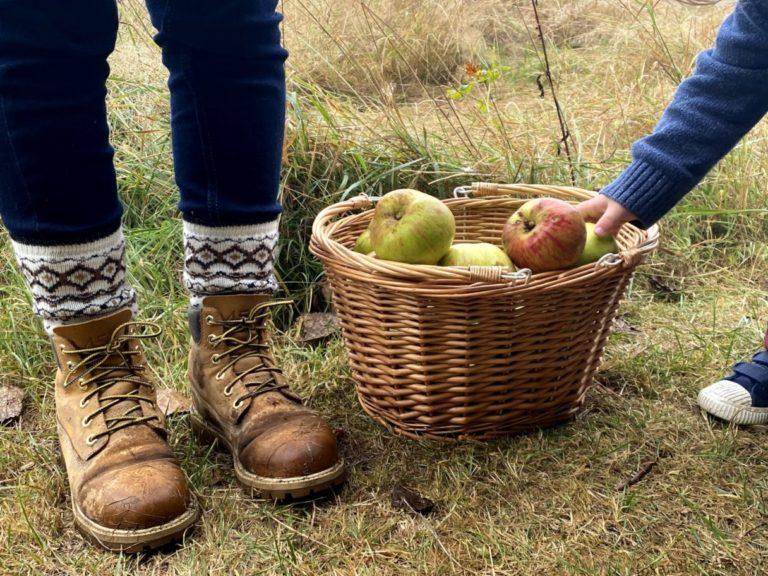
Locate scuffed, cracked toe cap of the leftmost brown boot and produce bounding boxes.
[80,461,191,530]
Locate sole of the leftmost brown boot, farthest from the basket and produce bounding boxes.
[72,497,200,554]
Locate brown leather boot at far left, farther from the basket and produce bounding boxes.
[52,310,198,552]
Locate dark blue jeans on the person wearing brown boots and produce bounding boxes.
[0,0,287,245]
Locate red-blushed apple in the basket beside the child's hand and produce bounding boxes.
[502,198,587,272]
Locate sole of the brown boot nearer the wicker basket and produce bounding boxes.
[190,411,347,502]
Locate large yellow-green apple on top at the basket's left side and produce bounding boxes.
[370,189,456,264]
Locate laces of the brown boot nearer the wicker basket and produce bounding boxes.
[205,300,299,409]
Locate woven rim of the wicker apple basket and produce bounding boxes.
[310,182,659,297]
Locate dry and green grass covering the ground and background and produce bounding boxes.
[0,0,768,576]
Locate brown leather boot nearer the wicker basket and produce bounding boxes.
[189,294,345,500]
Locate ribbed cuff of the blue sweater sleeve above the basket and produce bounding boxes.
[600,160,693,228]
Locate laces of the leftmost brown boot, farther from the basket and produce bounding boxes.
[61,321,162,446]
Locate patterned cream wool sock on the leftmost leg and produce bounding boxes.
[13,229,136,333]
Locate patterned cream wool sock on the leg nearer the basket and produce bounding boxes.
[184,220,278,304]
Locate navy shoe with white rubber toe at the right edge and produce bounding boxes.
[697,336,768,424]
